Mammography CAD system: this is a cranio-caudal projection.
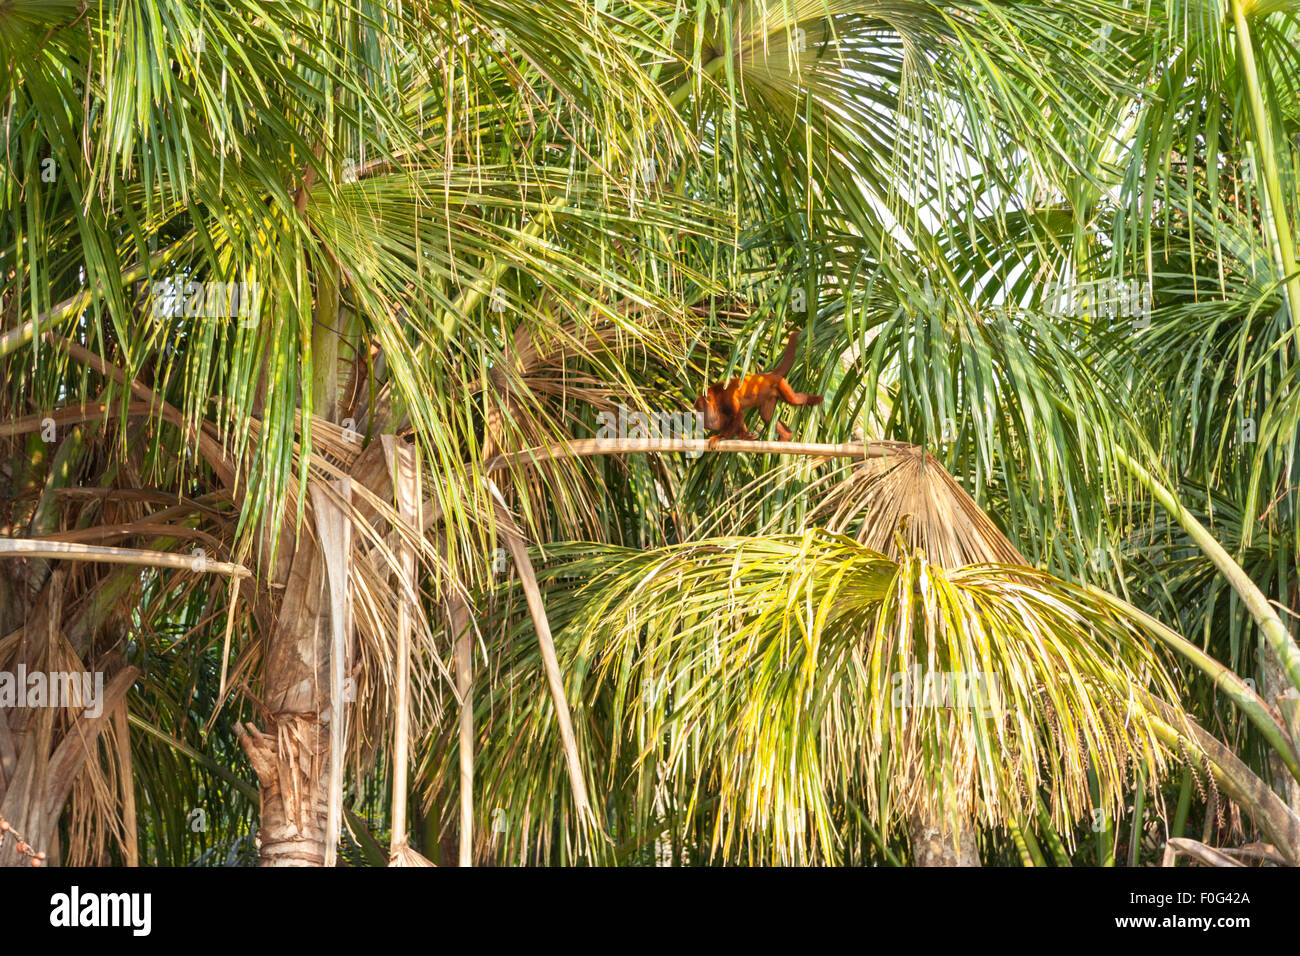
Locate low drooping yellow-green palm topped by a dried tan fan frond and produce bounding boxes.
[441,446,1177,865]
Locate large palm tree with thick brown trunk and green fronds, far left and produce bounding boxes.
[0,3,711,864]
